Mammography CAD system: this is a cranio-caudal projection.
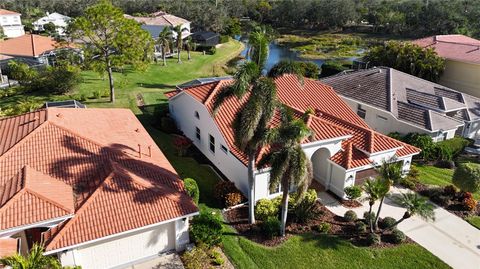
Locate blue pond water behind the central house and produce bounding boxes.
[240,39,361,73]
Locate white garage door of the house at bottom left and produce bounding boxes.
[75,222,175,269]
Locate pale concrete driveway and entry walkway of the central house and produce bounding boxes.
[318,188,480,269]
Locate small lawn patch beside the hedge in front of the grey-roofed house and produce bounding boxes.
[416,165,480,200]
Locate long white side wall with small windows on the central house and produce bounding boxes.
[169,94,248,197]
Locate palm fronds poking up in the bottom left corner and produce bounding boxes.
[0,243,61,269]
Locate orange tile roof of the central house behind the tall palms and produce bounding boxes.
[170,75,420,169]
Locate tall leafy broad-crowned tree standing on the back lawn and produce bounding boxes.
[68,0,153,102]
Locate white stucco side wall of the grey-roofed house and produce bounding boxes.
[340,96,456,142]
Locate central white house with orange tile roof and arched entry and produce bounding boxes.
[167,75,419,200]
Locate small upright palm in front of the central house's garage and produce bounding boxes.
[373,158,402,229]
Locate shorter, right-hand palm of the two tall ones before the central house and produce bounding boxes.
[259,108,312,236]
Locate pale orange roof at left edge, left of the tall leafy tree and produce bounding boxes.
[0,34,73,57]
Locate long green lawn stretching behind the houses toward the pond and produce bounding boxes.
[0,40,244,113]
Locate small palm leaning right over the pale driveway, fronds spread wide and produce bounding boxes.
[389,193,435,229]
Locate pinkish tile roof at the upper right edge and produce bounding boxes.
[413,35,480,64]
